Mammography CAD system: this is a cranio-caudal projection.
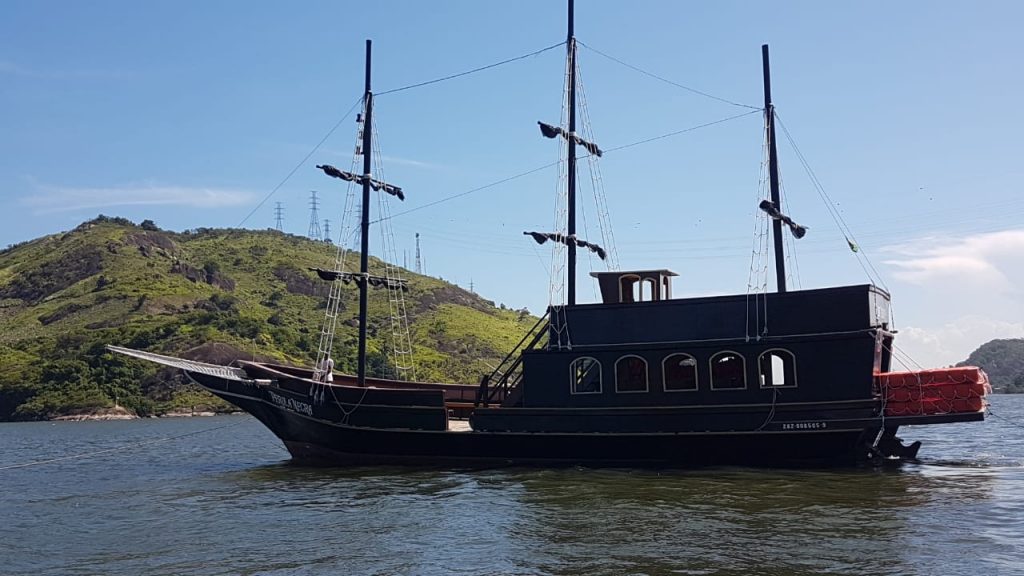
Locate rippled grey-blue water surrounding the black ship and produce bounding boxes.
[0,397,1024,576]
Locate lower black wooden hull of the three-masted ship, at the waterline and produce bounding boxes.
[188,366,982,467]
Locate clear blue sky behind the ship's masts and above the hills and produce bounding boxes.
[0,0,1024,365]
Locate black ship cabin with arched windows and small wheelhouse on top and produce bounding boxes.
[503,270,892,409]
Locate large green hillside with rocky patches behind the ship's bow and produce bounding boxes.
[0,216,537,420]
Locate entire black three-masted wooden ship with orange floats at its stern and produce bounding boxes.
[110,0,989,465]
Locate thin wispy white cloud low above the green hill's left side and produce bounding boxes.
[22,182,255,214]
